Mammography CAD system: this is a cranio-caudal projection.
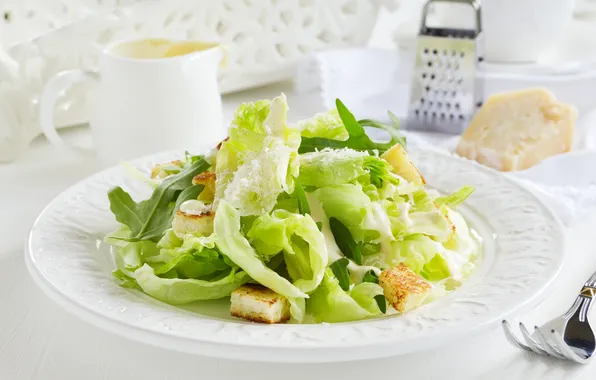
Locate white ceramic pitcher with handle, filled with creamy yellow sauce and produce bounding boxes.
[40,39,225,163]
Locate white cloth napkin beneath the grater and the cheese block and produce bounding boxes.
[295,49,596,226]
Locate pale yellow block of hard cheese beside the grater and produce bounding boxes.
[456,88,577,171]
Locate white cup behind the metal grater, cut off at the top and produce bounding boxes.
[436,0,574,62]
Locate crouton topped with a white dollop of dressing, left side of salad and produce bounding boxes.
[172,200,215,238]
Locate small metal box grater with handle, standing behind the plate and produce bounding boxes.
[406,0,483,134]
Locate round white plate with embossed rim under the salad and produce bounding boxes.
[26,148,564,362]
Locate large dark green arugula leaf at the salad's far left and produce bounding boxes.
[108,157,210,241]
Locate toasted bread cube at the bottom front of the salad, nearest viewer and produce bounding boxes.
[230,284,290,324]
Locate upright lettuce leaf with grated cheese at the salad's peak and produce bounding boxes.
[215,94,300,216]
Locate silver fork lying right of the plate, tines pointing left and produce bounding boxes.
[502,272,596,364]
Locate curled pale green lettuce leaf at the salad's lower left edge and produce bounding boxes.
[109,227,250,304]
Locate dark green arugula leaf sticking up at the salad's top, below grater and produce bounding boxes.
[298,99,406,154]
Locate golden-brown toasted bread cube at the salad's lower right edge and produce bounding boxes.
[379,263,432,313]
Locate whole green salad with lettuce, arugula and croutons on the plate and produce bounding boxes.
[106,94,478,323]
